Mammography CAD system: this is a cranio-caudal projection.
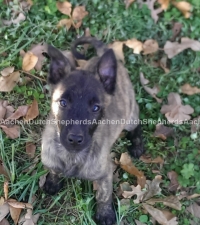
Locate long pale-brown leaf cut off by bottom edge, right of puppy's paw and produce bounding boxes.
[142,203,178,225]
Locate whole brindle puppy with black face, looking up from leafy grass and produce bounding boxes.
[41,37,144,225]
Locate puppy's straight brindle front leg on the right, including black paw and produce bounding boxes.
[95,168,116,225]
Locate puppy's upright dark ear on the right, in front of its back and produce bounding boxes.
[97,49,117,94]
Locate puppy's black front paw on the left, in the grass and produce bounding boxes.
[43,173,64,195]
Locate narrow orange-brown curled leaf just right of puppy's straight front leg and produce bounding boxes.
[119,152,146,188]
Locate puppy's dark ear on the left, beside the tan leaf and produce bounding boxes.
[48,45,71,84]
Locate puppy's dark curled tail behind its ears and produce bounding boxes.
[71,36,107,59]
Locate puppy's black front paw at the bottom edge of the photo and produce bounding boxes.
[95,203,116,225]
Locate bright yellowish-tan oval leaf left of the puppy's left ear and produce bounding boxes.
[22,52,38,72]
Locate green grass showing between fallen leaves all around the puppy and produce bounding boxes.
[0,0,200,225]
